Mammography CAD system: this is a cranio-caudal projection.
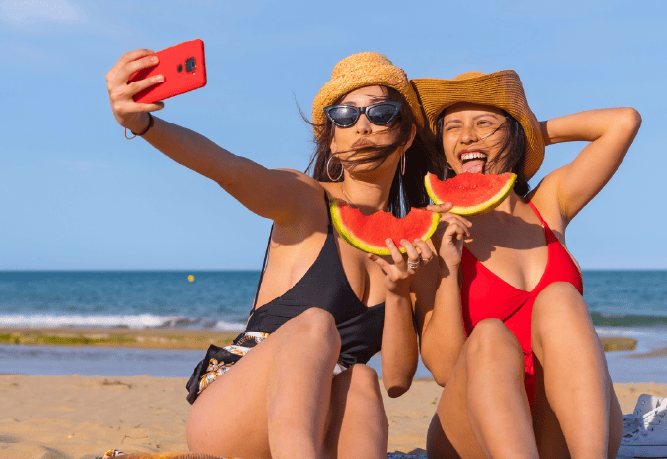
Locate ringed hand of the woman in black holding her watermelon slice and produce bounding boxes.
[368,238,434,295]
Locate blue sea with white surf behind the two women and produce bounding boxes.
[0,271,667,331]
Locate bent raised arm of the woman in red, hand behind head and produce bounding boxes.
[533,108,641,226]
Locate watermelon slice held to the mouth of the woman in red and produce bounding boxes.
[424,172,516,215]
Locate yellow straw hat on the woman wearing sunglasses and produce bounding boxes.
[313,53,424,135]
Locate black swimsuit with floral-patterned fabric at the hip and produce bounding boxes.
[186,194,385,403]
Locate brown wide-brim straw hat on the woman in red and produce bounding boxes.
[412,70,544,179]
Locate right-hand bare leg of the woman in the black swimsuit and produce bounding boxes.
[325,364,389,459]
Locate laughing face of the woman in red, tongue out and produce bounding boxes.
[442,102,508,174]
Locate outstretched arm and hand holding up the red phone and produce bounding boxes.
[106,49,321,222]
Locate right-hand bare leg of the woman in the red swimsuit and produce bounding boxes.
[531,282,623,458]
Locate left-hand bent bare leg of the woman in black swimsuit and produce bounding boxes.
[186,308,340,459]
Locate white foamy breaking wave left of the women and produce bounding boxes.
[0,314,245,331]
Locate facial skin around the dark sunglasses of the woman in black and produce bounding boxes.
[330,85,410,174]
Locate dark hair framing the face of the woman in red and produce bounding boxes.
[436,110,530,196]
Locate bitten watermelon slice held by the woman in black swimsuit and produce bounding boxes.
[330,200,440,255]
